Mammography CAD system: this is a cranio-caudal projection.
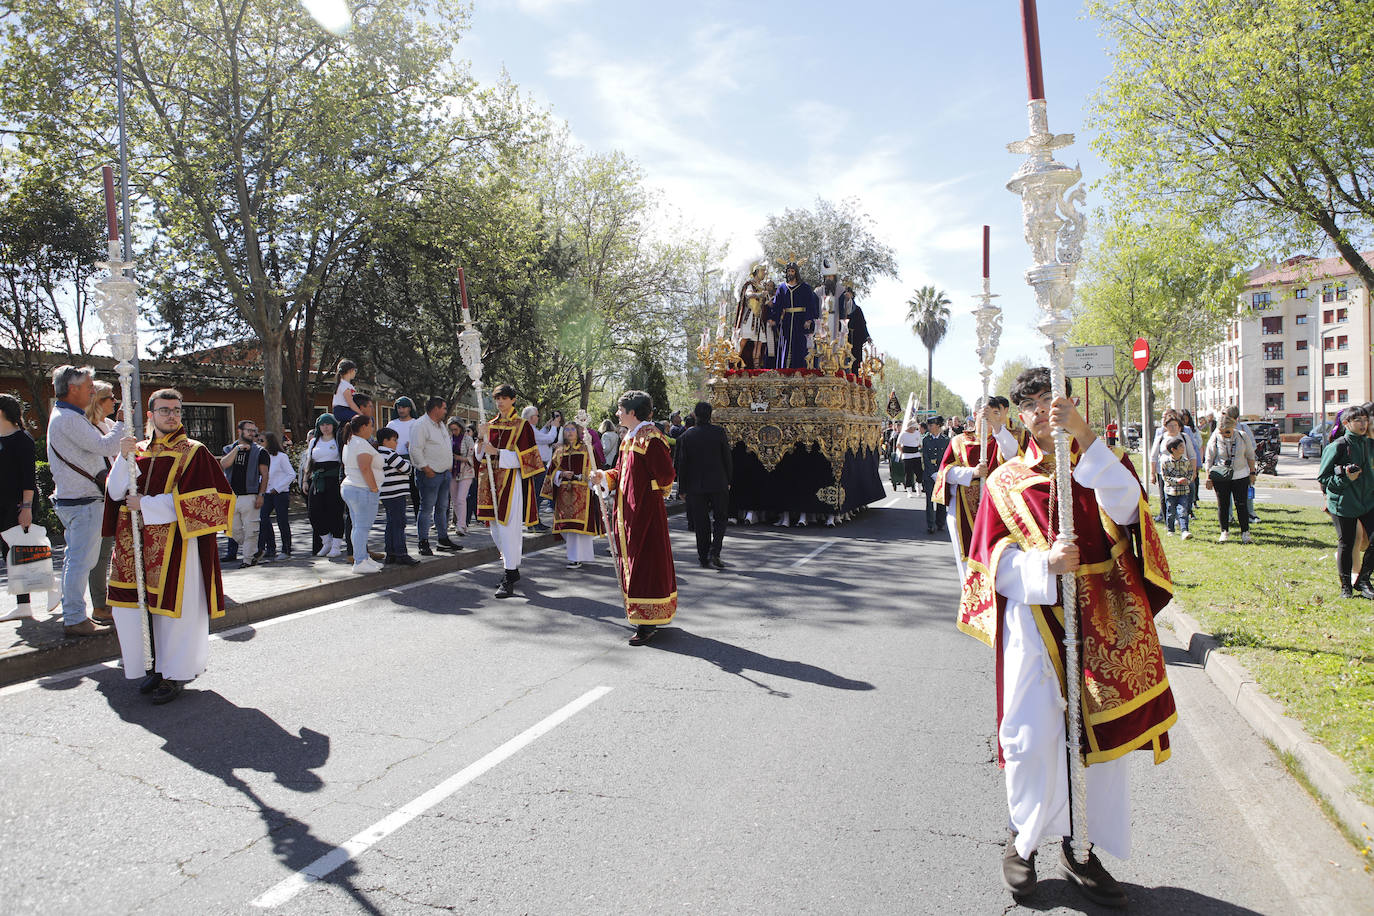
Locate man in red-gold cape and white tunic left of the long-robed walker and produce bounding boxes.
[477,385,544,597]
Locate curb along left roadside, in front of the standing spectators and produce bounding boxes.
[0,500,687,687]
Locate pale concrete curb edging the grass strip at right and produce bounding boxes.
[1164,604,1374,838]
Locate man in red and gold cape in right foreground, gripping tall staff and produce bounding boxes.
[959,368,1178,906]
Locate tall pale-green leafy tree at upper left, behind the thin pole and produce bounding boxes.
[0,0,515,433]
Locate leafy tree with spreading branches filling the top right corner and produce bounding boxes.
[1088,0,1374,288]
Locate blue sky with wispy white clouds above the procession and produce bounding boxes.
[458,0,1110,400]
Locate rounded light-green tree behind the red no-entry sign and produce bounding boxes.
[1074,213,1246,433]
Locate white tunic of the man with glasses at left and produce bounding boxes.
[107,456,214,681]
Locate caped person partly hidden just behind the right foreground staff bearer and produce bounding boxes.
[932,396,1026,582]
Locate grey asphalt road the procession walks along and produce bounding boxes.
[0,496,1374,915]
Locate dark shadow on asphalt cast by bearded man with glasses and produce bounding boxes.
[96,672,382,915]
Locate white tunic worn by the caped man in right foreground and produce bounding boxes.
[996,439,1140,858]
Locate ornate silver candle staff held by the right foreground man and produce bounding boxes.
[1007,99,1090,862]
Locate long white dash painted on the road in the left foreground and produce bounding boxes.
[253,687,611,909]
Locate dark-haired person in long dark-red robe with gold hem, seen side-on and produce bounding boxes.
[592,391,677,645]
